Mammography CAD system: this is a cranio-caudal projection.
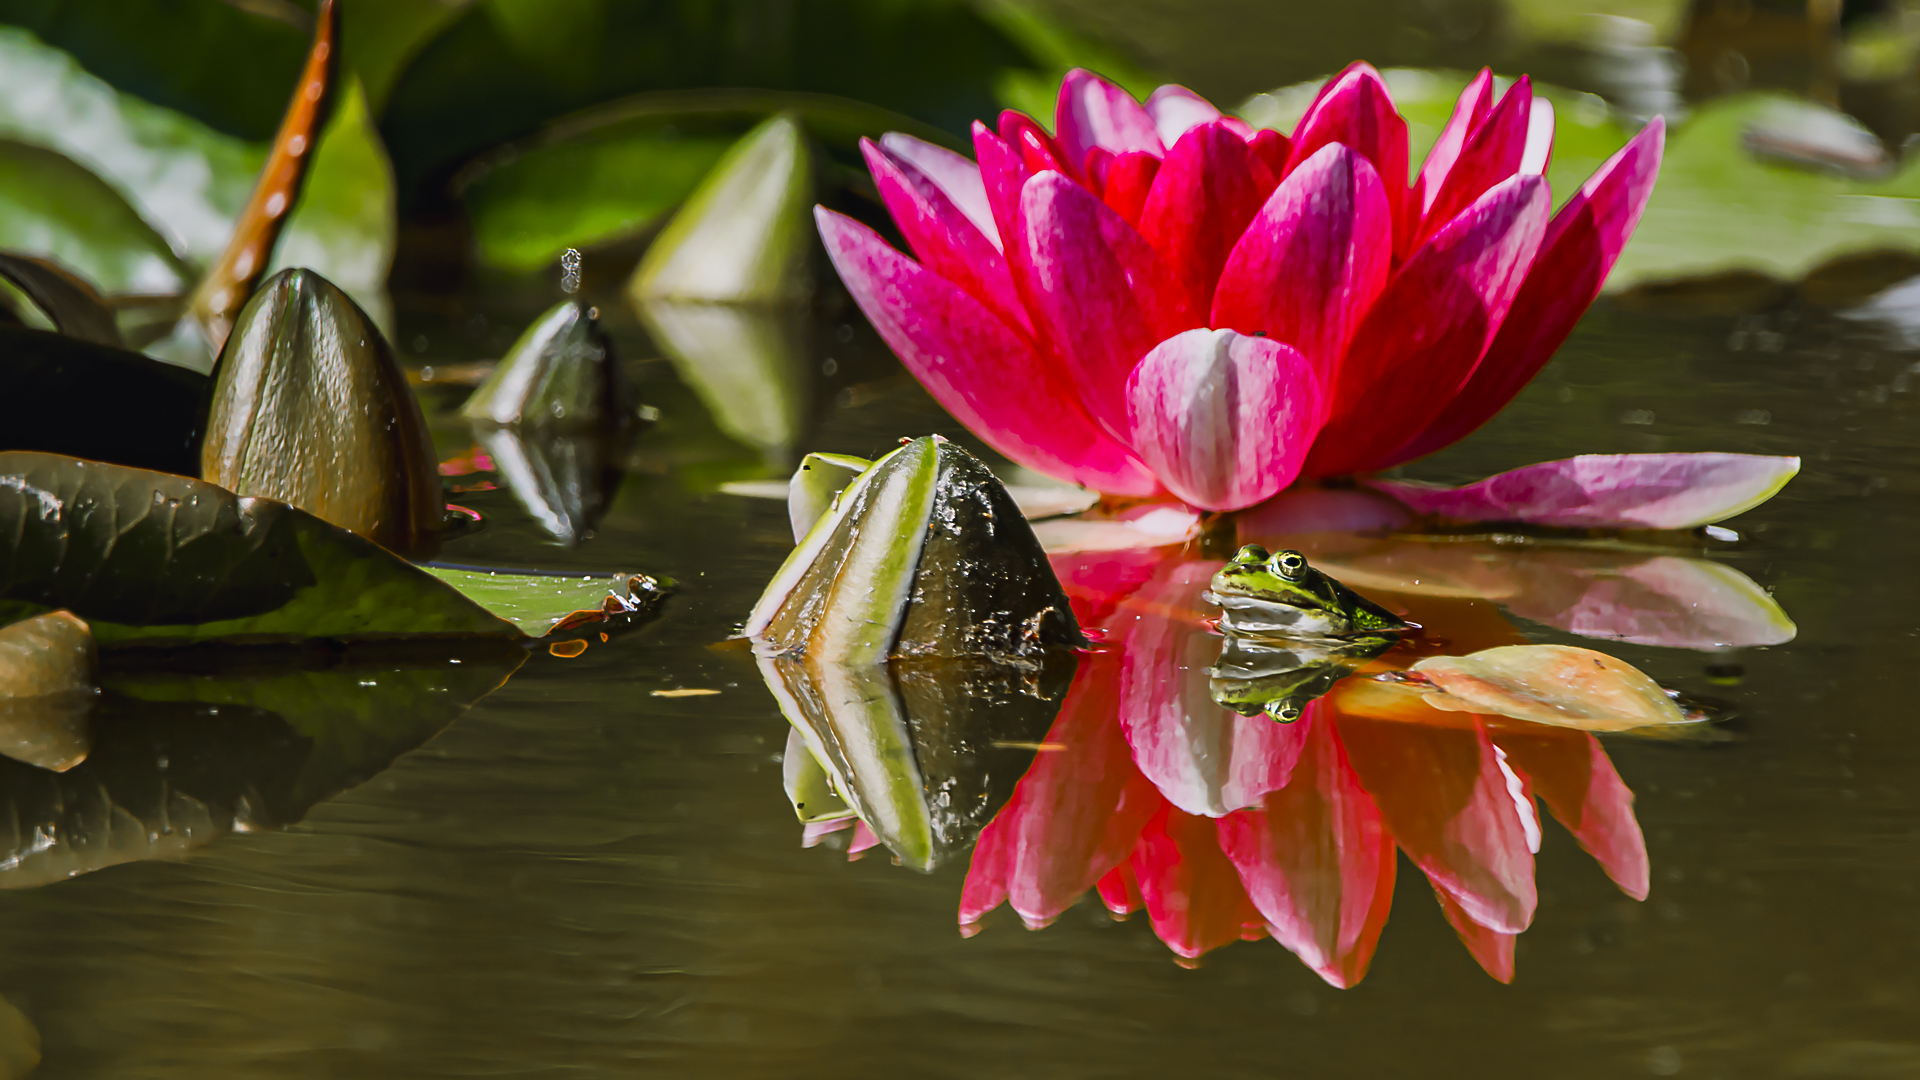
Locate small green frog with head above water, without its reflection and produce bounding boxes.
[1200,544,1413,644]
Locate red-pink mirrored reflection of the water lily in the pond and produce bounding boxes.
[775,518,1791,986]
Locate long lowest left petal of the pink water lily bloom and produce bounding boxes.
[814,209,1158,496]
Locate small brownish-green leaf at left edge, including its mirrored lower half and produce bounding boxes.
[0,611,98,773]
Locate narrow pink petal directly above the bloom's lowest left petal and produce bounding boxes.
[860,138,1033,334]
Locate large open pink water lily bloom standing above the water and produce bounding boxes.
[816,63,1665,509]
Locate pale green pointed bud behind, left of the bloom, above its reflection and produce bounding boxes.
[628,115,814,304]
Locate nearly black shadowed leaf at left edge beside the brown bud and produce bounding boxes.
[0,325,213,475]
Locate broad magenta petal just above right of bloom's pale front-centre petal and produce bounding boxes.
[1212,146,1394,380]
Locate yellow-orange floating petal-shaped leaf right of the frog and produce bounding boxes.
[1411,646,1686,732]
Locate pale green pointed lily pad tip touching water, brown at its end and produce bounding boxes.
[424,565,668,638]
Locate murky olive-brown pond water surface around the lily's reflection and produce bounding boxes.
[0,270,1920,1076]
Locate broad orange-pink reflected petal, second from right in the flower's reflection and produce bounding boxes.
[1338,715,1538,934]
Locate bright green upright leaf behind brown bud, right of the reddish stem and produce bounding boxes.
[269,76,397,332]
